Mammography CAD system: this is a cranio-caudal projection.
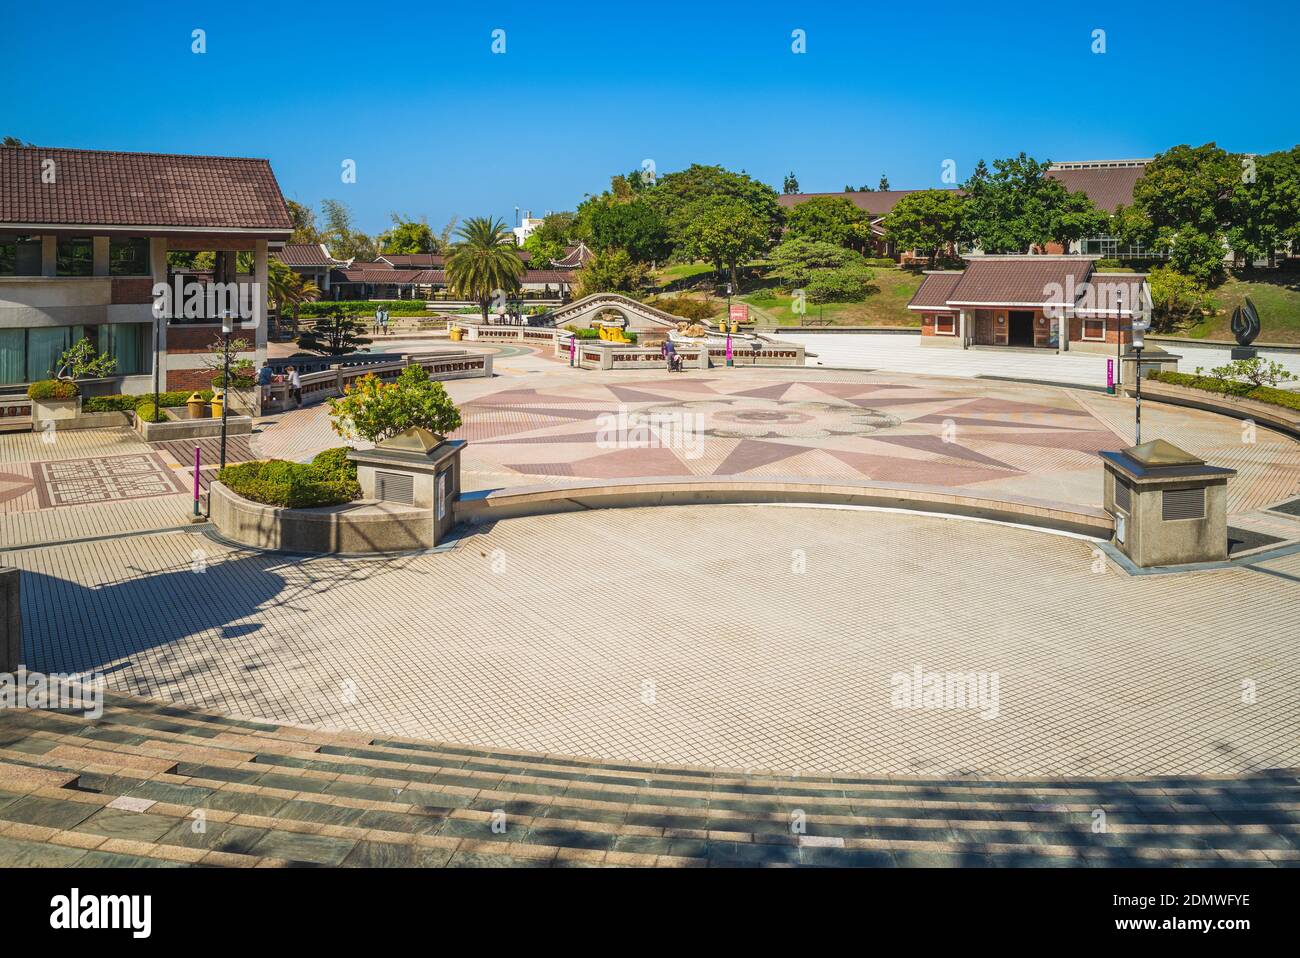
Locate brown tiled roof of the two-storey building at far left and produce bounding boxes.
[0,147,294,233]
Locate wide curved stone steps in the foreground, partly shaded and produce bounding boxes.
[0,695,1300,867]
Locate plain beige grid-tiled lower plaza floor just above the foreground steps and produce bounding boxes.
[10,506,1300,775]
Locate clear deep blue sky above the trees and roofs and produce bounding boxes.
[0,0,1300,231]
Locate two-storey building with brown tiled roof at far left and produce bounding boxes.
[0,147,293,393]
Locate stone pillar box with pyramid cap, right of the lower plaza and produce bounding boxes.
[1101,439,1236,568]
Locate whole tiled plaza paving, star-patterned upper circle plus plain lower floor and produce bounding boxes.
[0,343,1300,776]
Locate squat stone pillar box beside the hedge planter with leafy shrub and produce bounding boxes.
[347,428,465,546]
